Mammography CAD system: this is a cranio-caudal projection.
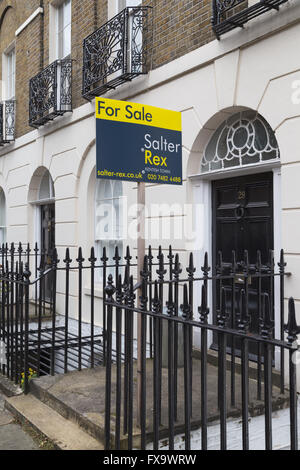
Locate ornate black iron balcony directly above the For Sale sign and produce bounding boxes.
[82,7,151,100]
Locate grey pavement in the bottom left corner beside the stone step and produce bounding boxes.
[0,393,39,450]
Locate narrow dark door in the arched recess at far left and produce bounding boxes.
[41,204,55,301]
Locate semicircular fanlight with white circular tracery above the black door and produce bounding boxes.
[201,110,280,173]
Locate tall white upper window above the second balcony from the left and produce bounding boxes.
[56,0,72,59]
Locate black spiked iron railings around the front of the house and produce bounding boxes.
[0,244,300,450]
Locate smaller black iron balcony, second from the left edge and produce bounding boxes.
[29,59,72,128]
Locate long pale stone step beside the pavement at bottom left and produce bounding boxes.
[5,394,104,450]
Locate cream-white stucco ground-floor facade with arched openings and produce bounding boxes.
[0,0,300,382]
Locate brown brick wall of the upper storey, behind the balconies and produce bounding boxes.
[0,0,214,137]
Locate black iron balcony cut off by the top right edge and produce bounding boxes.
[212,0,288,39]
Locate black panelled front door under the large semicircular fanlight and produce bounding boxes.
[212,173,274,352]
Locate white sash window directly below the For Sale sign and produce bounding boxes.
[95,180,123,271]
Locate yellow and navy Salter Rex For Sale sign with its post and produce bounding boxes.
[96,98,182,430]
